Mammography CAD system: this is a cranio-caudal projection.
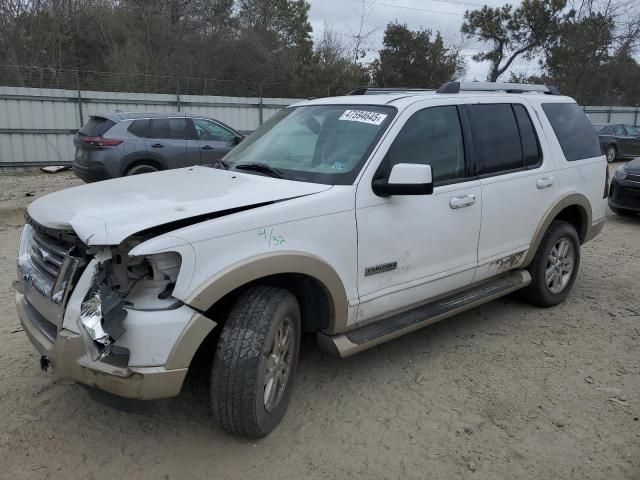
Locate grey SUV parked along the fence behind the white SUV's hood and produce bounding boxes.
[73,113,243,182]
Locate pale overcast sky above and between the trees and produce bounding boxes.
[307,0,537,80]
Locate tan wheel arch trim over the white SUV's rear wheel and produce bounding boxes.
[523,193,592,266]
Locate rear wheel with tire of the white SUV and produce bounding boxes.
[522,220,580,307]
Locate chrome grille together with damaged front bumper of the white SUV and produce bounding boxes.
[14,225,216,399]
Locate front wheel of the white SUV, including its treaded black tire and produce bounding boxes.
[211,286,301,438]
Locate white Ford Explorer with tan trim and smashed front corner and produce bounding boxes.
[16,82,607,437]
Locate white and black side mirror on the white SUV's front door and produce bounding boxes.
[373,163,433,197]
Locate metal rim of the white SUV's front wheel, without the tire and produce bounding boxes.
[263,317,295,412]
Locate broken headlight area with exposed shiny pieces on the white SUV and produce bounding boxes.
[80,251,181,359]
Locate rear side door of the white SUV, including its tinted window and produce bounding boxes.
[467,99,558,281]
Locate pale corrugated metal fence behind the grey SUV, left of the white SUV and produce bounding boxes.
[0,87,298,166]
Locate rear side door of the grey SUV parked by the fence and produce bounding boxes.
[146,117,194,168]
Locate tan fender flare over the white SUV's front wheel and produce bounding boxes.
[185,251,349,334]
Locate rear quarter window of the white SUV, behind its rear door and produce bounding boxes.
[542,103,602,162]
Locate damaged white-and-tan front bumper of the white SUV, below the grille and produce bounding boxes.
[16,293,215,400]
